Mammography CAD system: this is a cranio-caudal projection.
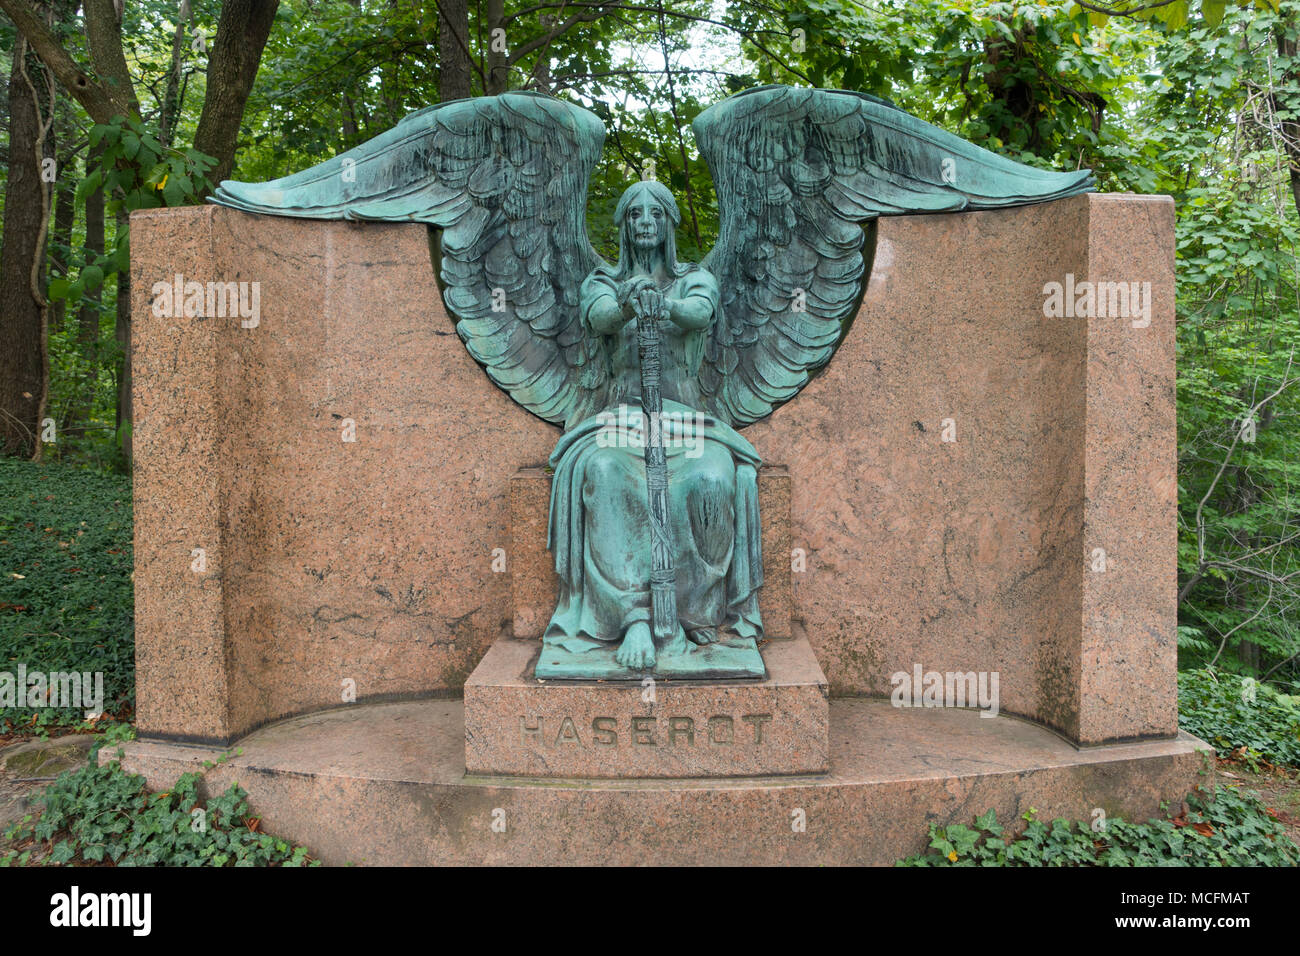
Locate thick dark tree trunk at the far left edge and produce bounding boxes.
[0,42,46,458]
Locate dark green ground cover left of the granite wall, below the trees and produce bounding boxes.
[0,459,135,731]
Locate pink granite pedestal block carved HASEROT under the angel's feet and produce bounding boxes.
[464,640,829,778]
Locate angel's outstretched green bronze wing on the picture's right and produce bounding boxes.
[694,86,1092,427]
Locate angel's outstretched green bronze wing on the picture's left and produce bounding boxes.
[212,94,607,425]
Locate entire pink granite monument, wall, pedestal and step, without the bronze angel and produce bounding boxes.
[111,188,1203,864]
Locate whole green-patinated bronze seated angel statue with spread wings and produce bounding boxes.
[215,86,1092,679]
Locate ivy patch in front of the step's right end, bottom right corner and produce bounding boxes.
[898,787,1300,866]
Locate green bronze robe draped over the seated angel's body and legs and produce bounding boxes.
[543,267,763,652]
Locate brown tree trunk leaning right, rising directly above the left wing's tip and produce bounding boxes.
[194,0,280,182]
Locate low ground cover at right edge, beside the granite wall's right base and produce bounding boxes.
[1178,669,1300,766]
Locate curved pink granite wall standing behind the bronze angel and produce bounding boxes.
[131,195,1177,743]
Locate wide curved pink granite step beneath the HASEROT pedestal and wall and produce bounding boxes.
[109,698,1212,866]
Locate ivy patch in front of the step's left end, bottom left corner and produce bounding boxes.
[0,761,317,866]
